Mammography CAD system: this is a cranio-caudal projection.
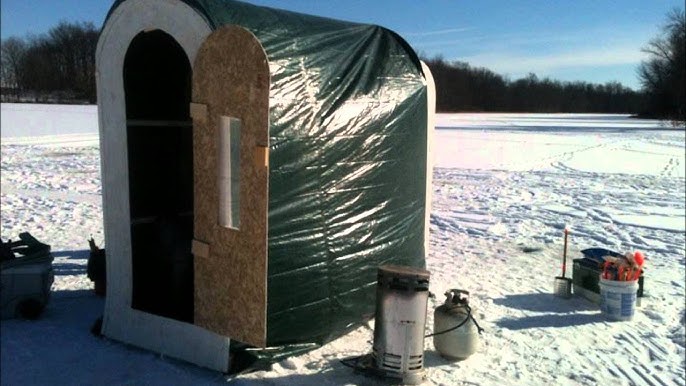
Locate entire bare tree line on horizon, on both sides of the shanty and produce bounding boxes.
[0,9,686,121]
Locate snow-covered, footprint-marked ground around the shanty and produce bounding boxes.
[0,104,686,386]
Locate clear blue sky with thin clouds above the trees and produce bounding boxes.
[0,0,684,89]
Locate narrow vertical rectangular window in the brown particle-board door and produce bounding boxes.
[218,116,241,229]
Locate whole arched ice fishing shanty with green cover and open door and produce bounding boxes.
[96,0,434,371]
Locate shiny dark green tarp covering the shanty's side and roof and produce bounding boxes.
[106,0,427,347]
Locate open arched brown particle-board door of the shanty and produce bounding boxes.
[191,26,269,347]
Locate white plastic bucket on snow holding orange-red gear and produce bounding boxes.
[598,277,638,320]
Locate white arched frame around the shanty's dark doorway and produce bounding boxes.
[96,0,230,372]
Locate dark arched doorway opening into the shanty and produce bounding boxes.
[123,30,194,323]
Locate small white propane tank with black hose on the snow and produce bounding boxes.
[432,289,479,360]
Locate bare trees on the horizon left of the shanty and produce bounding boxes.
[0,22,100,103]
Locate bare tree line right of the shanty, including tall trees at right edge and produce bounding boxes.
[423,9,686,122]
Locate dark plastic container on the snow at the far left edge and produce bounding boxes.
[0,232,55,319]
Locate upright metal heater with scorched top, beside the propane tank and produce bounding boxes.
[372,265,429,384]
